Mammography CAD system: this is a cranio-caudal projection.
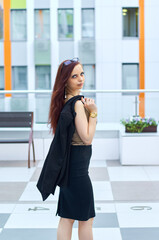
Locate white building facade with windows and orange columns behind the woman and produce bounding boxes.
[0,0,159,122]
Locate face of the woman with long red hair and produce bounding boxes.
[67,64,85,91]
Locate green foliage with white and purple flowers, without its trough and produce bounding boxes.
[120,117,159,133]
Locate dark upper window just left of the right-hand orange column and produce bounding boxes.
[122,8,138,37]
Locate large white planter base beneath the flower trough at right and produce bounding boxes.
[119,129,159,165]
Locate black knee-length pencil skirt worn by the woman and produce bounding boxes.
[56,100,96,221]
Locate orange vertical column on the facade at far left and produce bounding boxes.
[3,0,12,97]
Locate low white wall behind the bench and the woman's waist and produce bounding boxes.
[0,138,119,161]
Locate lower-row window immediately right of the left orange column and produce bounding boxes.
[12,66,27,90]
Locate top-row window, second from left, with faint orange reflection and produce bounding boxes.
[35,9,50,39]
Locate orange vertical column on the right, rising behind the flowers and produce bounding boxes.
[139,0,145,117]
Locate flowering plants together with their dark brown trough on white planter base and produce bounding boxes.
[120,116,159,133]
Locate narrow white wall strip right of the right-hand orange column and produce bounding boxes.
[145,0,159,119]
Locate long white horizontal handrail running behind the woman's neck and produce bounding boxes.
[0,89,159,94]
